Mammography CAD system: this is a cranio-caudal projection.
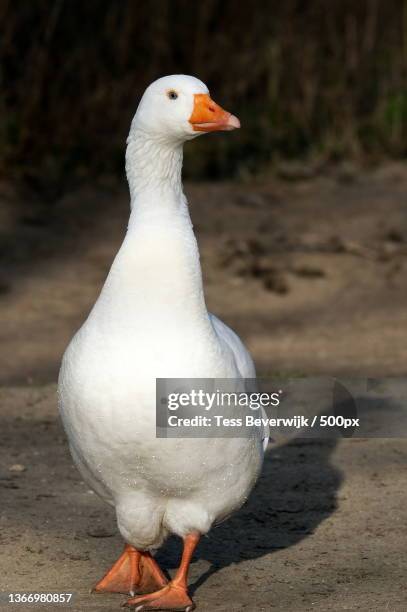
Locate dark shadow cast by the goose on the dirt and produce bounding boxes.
[157,438,343,593]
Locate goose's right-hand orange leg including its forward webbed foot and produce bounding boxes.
[123,533,200,612]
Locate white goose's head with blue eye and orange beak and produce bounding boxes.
[130,74,240,143]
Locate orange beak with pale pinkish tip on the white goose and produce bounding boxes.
[189,94,240,132]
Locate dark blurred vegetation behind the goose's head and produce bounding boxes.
[0,0,407,187]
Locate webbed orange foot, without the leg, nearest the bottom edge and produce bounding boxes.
[123,582,195,612]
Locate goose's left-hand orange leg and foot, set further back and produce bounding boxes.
[92,544,168,595]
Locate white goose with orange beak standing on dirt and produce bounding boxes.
[59,75,266,610]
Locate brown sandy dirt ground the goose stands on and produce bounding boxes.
[0,164,407,612]
